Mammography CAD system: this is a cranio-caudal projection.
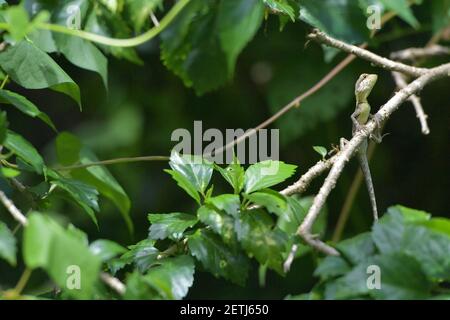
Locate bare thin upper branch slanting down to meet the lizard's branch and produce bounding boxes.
[308,29,428,77]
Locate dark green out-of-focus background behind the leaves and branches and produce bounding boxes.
[0,0,450,299]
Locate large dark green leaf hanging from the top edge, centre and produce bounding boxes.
[161,0,263,94]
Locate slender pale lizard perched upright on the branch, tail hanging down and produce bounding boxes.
[341,73,382,221]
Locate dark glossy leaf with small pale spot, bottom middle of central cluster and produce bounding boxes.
[188,229,249,285]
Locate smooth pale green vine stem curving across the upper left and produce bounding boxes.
[0,0,190,47]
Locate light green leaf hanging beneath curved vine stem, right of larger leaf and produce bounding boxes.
[54,34,108,89]
